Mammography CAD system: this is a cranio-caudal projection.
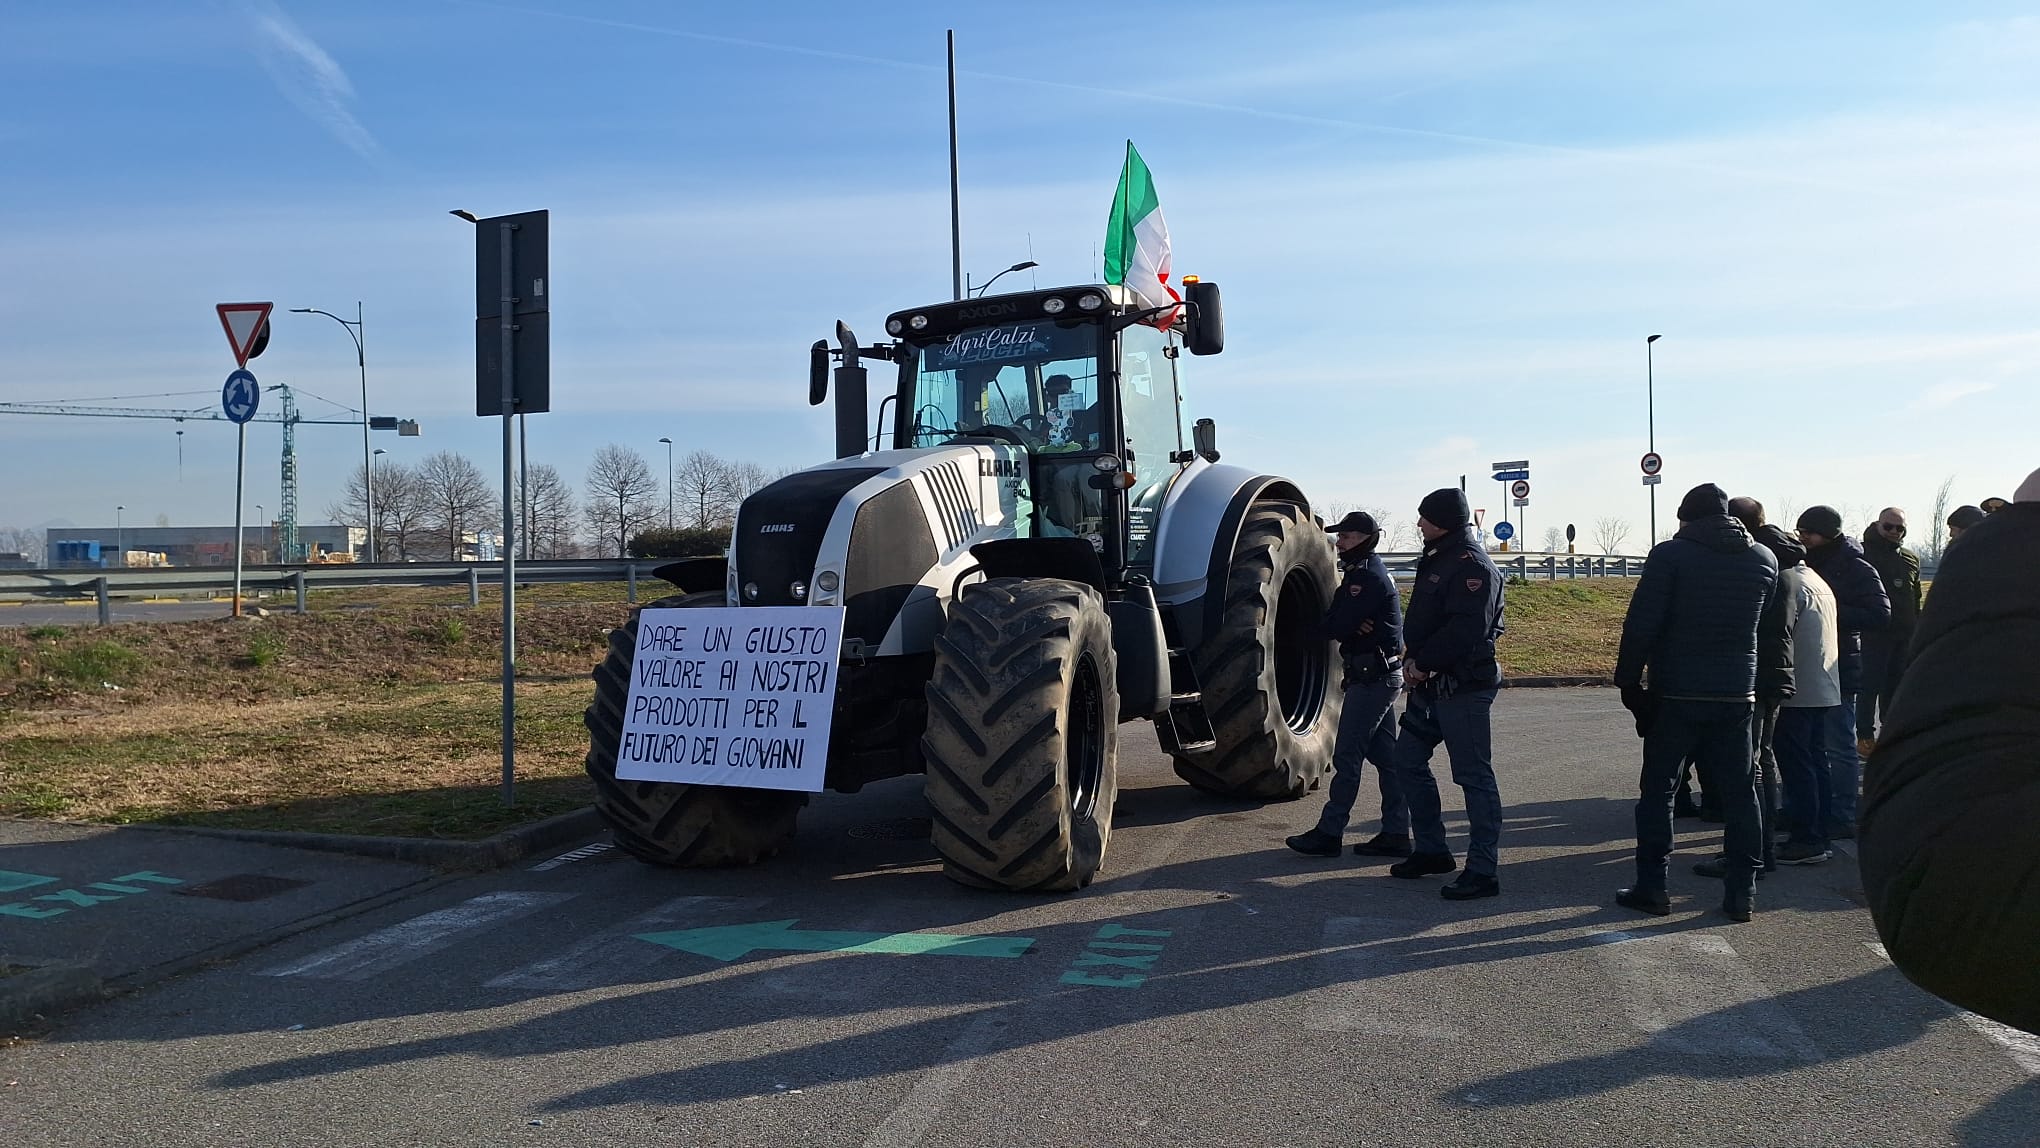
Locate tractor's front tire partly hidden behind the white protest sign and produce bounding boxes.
[583,593,808,867]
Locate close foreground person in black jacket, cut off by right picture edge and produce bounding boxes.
[1863,471,2040,1032]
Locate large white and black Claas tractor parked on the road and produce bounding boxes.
[588,277,1342,891]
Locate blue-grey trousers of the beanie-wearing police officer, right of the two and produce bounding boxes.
[1395,687,1501,877]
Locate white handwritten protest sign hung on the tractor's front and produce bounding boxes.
[616,606,843,793]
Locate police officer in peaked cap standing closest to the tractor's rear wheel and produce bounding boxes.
[1285,510,1410,856]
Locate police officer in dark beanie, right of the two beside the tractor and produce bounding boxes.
[1389,487,1501,901]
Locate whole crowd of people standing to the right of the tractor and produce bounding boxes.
[1287,471,2040,1028]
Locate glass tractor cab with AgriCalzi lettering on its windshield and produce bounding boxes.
[885,283,1224,571]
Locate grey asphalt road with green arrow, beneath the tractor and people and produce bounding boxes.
[0,689,2040,1148]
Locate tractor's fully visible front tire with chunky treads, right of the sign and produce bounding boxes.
[920,577,1120,893]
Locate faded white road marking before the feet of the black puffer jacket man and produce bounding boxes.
[1593,932,1820,1060]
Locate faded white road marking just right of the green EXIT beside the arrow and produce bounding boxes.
[1304,918,1467,1040]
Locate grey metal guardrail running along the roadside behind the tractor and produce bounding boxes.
[0,553,1642,626]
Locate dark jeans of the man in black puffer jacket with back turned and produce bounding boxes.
[1636,697,1763,893]
